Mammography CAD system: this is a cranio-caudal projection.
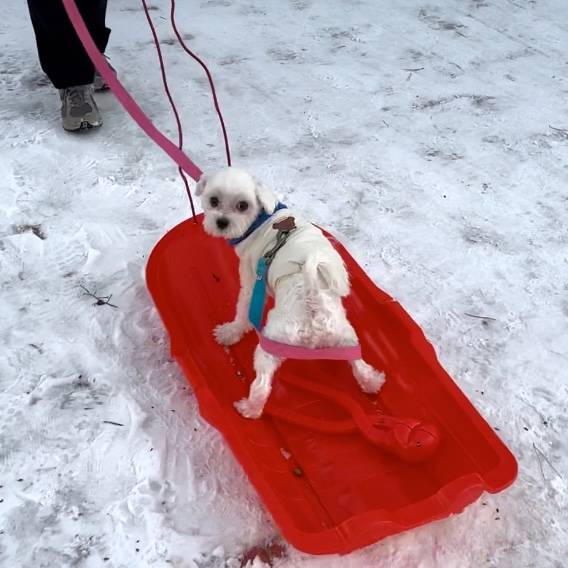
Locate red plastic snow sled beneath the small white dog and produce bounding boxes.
[147,220,517,554]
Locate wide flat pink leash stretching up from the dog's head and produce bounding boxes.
[62,0,202,181]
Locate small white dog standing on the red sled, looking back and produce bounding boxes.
[196,168,385,418]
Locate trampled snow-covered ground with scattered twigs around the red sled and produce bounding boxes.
[0,0,568,568]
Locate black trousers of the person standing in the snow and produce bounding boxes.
[28,0,110,89]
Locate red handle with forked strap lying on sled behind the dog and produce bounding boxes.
[266,375,440,463]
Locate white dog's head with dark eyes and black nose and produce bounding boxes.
[195,168,278,239]
